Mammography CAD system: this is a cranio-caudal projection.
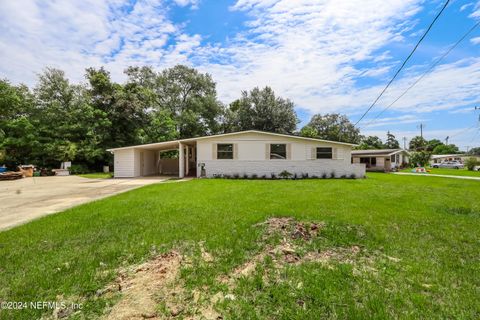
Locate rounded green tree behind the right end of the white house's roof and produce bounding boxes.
[300,113,361,143]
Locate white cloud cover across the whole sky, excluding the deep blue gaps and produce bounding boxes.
[0,0,480,139]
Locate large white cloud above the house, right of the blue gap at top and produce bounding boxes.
[197,0,420,112]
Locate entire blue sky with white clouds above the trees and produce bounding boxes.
[0,0,480,149]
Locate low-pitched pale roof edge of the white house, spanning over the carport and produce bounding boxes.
[107,130,356,152]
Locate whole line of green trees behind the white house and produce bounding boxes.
[0,65,470,170]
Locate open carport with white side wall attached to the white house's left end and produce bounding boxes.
[108,139,197,178]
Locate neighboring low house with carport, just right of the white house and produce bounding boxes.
[352,149,409,172]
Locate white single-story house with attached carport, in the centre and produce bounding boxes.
[108,130,365,178]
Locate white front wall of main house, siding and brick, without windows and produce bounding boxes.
[197,134,365,177]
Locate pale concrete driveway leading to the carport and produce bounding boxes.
[0,176,169,230]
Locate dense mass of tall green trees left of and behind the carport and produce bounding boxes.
[0,66,223,169]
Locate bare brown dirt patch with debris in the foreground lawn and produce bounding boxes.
[97,218,382,320]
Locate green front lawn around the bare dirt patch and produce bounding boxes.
[0,173,480,319]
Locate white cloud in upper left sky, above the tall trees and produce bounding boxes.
[0,0,199,85]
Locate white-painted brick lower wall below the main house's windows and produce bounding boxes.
[198,160,365,178]
